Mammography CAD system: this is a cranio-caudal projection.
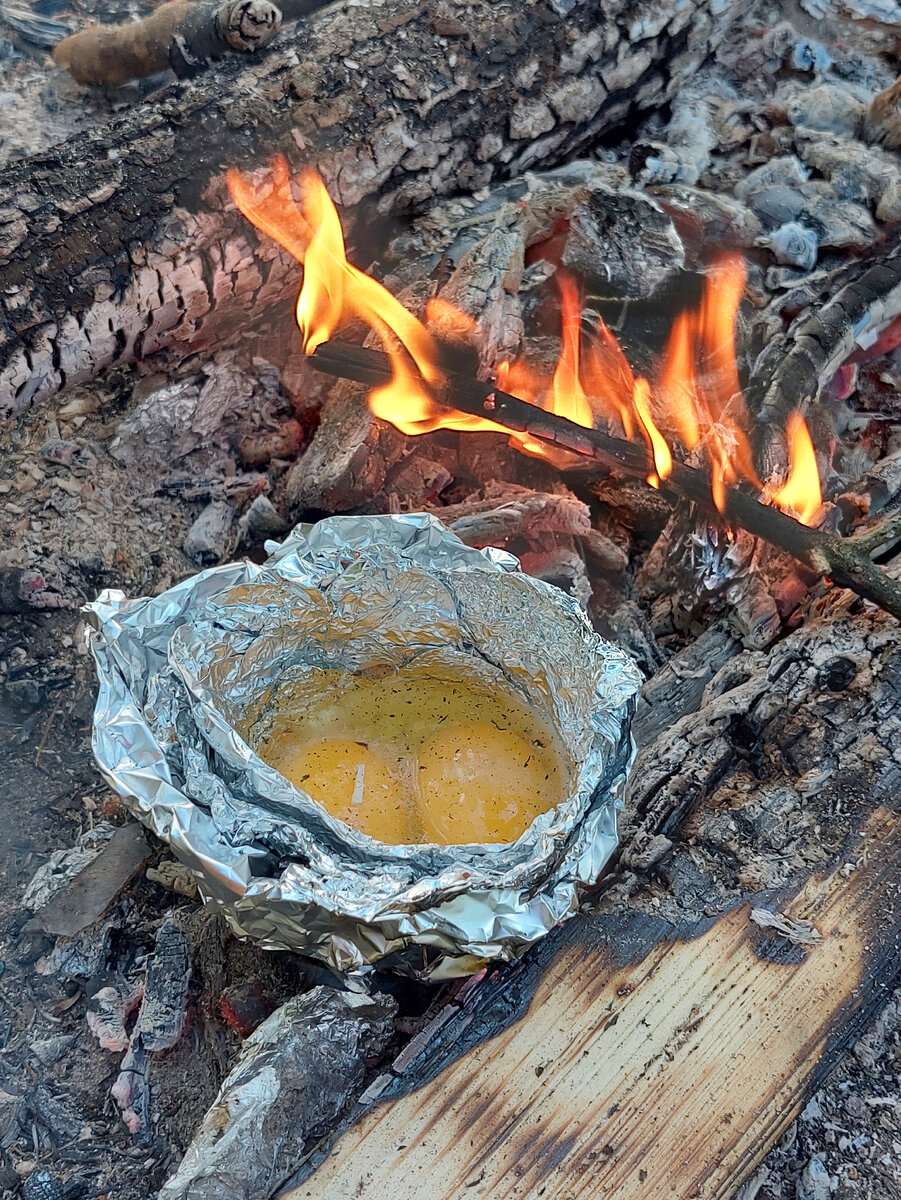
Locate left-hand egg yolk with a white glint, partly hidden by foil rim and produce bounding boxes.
[269,738,422,845]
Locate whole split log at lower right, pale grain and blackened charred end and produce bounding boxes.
[288,614,901,1200]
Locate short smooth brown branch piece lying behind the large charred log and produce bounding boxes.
[53,0,282,86]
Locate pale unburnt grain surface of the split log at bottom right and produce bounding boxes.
[289,810,901,1200]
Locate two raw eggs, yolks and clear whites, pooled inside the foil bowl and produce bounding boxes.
[254,670,564,845]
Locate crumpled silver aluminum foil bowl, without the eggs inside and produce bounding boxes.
[86,514,641,978]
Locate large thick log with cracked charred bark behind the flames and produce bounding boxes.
[0,0,744,418]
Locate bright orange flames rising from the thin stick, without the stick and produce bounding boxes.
[228,158,822,522]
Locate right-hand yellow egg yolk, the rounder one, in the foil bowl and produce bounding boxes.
[419,724,560,845]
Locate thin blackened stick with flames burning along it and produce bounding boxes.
[310,341,901,619]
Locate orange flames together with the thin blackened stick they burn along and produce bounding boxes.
[228,158,901,616]
